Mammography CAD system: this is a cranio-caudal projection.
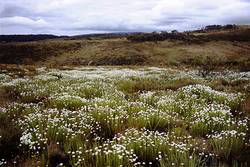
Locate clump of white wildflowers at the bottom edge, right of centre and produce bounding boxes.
[87,129,202,166]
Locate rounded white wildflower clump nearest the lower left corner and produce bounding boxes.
[18,109,99,152]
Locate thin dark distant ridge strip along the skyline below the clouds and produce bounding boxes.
[0,24,250,43]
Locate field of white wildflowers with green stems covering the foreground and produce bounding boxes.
[0,67,250,167]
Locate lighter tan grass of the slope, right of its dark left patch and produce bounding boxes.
[36,39,250,70]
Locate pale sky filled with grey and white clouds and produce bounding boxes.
[0,0,250,35]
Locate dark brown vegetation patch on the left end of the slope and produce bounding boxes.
[0,41,80,64]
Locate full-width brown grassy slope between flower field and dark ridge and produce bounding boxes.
[0,29,250,71]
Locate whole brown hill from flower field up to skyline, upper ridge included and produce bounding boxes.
[0,26,250,71]
